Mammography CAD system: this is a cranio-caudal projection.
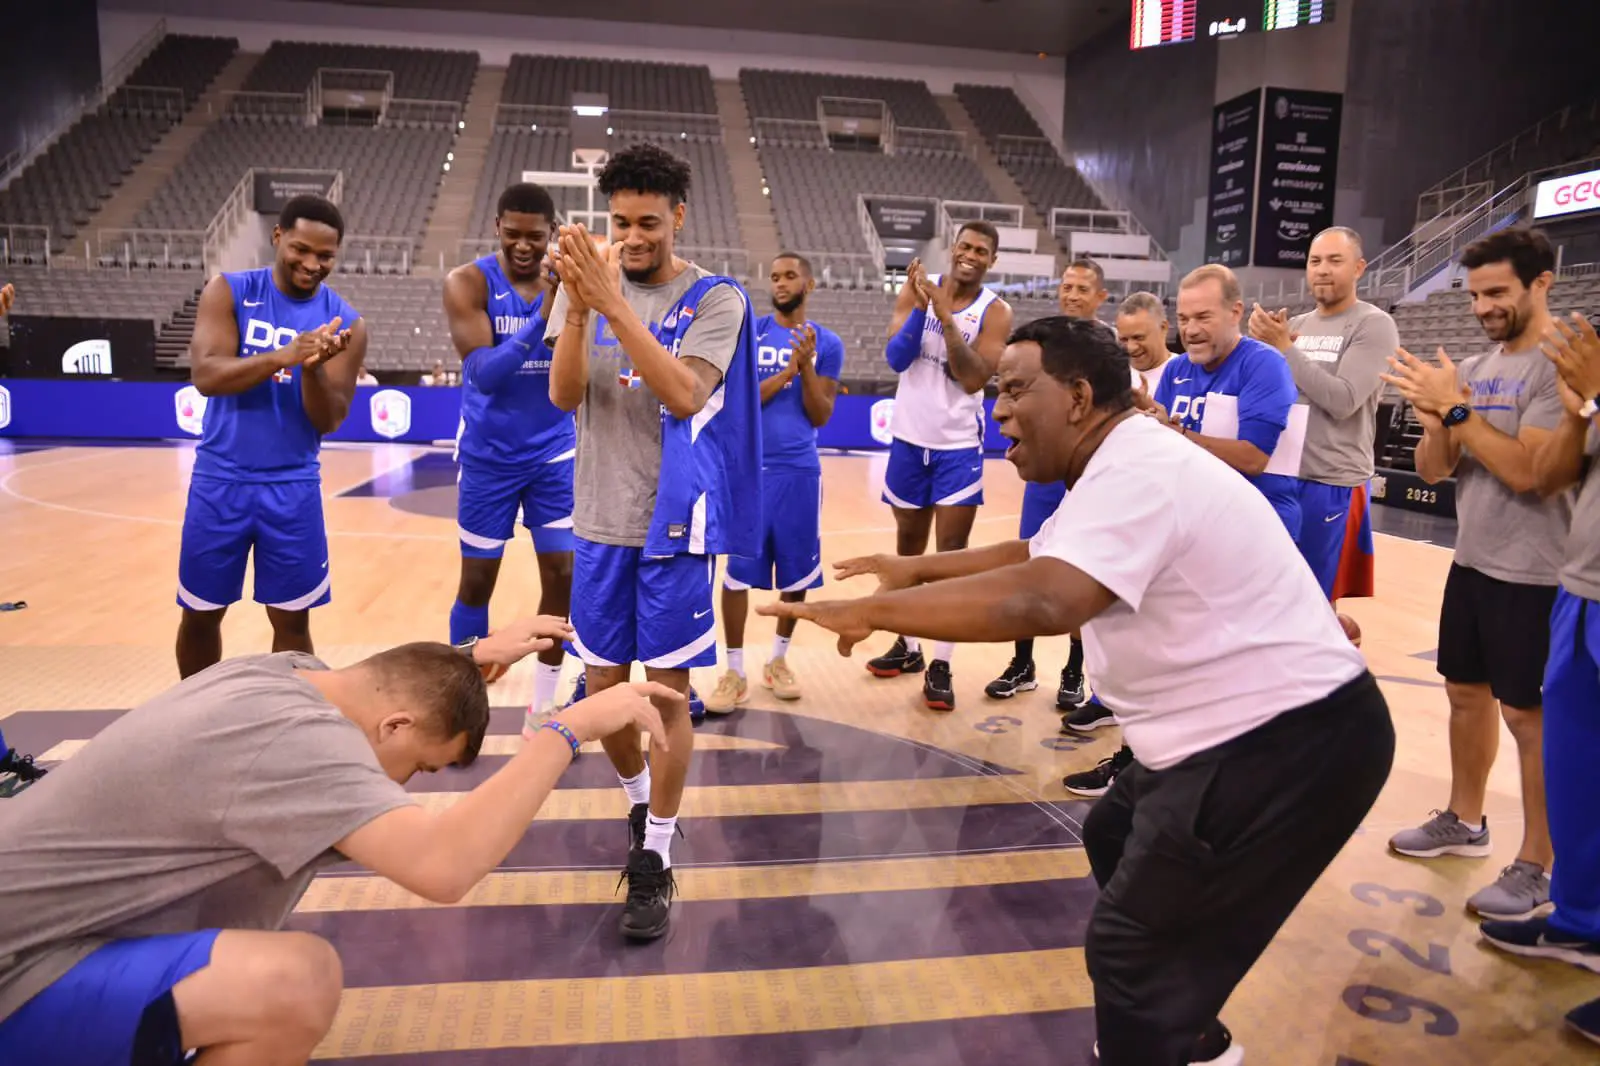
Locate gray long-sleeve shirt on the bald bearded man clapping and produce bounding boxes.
[1285,301,1400,487]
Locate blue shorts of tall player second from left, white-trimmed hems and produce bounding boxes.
[456,456,573,559]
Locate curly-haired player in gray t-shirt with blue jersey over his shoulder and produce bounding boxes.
[546,144,762,940]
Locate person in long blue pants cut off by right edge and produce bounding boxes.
[1482,315,1600,1011]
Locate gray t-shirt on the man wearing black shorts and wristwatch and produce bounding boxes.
[1456,346,1573,586]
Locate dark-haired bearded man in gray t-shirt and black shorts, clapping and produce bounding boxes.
[1384,227,1571,919]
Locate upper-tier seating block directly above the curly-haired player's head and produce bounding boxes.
[501,54,717,115]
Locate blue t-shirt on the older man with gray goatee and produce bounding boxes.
[1154,336,1299,506]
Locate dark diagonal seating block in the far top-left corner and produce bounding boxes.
[0,37,238,253]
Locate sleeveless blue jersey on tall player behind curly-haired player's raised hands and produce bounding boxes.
[458,256,578,466]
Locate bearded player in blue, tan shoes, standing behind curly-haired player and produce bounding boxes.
[706,251,845,714]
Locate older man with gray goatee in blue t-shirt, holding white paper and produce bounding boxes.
[1152,262,1306,538]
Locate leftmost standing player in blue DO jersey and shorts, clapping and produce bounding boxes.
[178,197,366,677]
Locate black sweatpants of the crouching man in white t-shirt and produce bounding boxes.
[1083,674,1395,1066]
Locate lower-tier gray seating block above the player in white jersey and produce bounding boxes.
[760,144,998,253]
